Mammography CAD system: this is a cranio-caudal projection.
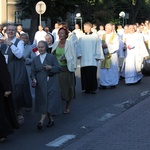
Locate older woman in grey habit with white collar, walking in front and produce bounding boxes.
[31,41,61,129]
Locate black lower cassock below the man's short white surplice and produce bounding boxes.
[81,66,97,91]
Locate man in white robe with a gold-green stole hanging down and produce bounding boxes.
[99,23,119,89]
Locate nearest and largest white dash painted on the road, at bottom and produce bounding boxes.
[46,134,76,147]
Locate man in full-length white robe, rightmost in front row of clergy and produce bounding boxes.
[125,25,149,84]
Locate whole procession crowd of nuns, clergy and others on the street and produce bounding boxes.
[0,21,150,142]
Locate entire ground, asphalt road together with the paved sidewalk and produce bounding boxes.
[0,69,150,150]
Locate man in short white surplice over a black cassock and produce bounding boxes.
[77,22,104,94]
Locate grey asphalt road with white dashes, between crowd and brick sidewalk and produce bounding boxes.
[0,67,150,150]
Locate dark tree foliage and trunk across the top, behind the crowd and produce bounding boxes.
[17,0,150,39]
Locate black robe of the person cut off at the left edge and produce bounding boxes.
[0,52,19,138]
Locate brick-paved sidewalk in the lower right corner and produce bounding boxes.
[62,97,150,150]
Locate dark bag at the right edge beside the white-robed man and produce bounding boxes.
[141,60,150,76]
